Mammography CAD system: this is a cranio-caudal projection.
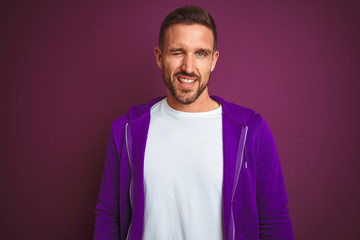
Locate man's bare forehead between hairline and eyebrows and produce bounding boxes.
[164,24,214,49]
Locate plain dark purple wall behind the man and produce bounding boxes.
[0,0,360,240]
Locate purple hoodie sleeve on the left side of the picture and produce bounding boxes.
[94,124,120,240]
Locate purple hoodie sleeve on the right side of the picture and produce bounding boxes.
[252,114,294,240]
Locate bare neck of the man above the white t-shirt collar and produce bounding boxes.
[166,90,220,112]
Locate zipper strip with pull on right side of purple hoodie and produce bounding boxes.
[228,126,248,239]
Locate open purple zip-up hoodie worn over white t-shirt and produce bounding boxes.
[94,96,294,240]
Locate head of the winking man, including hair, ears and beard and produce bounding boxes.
[155,6,219,105]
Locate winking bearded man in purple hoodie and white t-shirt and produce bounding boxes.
[95,6,293,240]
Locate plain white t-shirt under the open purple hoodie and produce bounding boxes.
[143,99,223,240]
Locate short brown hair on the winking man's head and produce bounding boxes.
[159,5,217,50]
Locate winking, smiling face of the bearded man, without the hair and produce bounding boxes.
[155,24,219,104]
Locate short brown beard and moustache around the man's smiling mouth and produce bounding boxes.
[163,71,210,105]
